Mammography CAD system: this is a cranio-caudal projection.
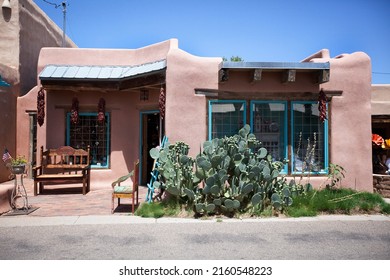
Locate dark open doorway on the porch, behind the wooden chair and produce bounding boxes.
[140,111,162,186]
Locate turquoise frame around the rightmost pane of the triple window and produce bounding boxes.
[290,101,329,175]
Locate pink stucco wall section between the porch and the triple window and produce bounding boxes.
[165,49,222,156]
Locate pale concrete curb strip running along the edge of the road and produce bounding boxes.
[0,215,390,228]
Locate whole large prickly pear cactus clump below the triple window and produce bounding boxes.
[150,125,303,215]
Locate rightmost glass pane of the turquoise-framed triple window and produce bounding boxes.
[292,102,327,173]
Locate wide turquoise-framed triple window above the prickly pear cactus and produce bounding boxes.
[209,100,328,174]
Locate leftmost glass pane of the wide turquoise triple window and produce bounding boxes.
[209,101,245,139]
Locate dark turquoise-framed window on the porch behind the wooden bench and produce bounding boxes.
[66,113,110,168]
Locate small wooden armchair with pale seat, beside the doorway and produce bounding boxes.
[111,160,139,215]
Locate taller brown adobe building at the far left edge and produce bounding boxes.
[0,0,76,182]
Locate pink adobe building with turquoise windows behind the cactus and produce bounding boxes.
[16,39,373,192]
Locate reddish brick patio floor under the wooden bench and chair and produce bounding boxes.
[0,178,147,217]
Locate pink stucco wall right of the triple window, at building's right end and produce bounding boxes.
[323,52,373,191]
